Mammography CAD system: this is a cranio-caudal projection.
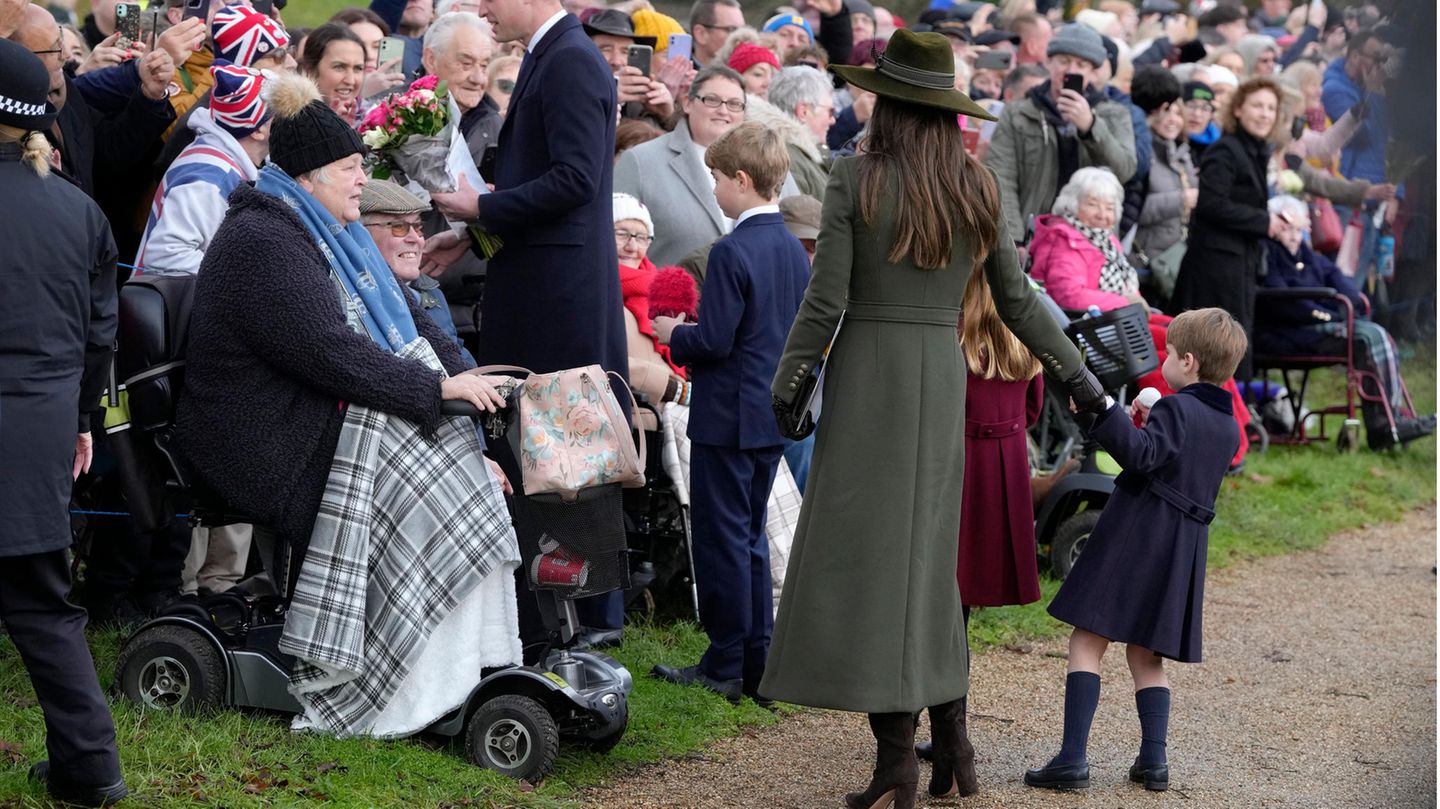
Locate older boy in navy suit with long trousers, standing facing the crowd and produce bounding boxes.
[651,122,809,702]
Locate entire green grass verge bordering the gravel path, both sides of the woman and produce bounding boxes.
[0,345,1436,809]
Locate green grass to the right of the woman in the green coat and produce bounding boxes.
[971,339,1436,649]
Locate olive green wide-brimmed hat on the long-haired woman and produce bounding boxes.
[829,29,996,121]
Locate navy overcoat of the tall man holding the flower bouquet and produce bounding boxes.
[477,14,629,377]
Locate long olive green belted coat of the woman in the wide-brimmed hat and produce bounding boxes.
[760,158,1080,713]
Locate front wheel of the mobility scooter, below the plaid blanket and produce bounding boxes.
[465,694,560,783]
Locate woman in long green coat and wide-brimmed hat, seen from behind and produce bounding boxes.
[760,29,1103,809]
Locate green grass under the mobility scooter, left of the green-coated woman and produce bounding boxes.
[0,613,778,808]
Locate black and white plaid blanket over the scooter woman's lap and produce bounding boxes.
[279,338,520,736]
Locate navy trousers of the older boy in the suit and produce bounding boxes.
[690,443,782,687]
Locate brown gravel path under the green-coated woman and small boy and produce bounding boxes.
[586,505,1436,809]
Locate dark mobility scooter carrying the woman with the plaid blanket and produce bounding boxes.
[109,275,634,783]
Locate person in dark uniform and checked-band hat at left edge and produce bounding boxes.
[0,39,125,806]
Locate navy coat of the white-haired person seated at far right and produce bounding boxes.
[1256,239,1362,354]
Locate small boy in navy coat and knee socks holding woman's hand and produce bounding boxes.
[1025,308,1247,790]
